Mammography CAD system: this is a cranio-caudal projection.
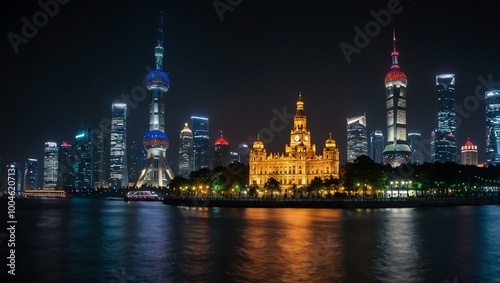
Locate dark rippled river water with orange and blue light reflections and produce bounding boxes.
[0,198,500,283]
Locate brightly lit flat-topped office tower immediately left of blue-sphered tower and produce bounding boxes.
[109,103,128,188]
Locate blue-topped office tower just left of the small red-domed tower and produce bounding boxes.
[191,116,210,171]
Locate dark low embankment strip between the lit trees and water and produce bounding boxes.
[163,196,500,208]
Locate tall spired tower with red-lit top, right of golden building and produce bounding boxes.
[382,29,411,167]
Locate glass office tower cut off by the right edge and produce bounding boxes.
[485,89,500,165]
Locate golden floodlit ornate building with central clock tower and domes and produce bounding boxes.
[249,93,339,189]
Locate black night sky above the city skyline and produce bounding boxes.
[0,0,500,171]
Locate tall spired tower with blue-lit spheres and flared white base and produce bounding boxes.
[136,13,174,187]
